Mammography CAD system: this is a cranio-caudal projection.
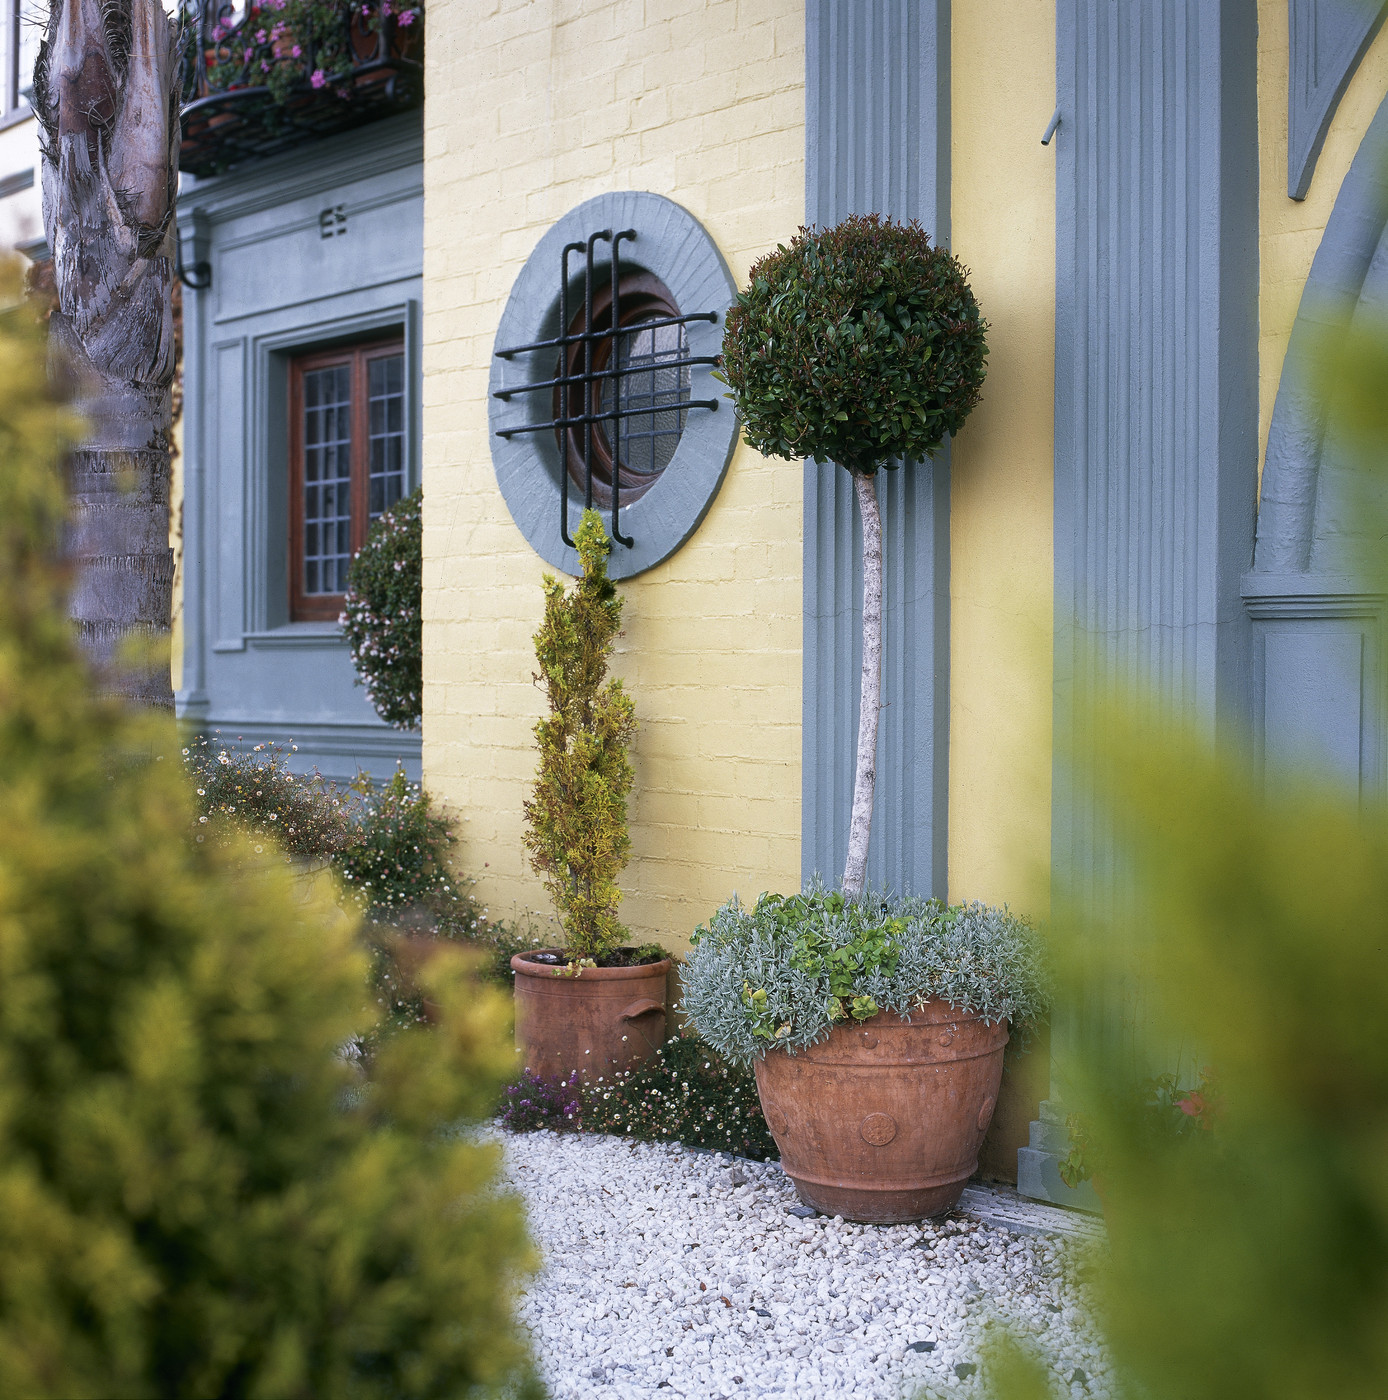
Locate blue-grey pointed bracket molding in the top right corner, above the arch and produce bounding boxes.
[1287,0,1388,199]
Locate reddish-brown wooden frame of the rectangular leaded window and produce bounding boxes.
[289,335,409,622]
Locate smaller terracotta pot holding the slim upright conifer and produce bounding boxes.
[511,949,669,1079]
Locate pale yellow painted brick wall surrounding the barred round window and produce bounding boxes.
[424,0,804,948]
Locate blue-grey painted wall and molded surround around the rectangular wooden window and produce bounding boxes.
[175,112,423,777]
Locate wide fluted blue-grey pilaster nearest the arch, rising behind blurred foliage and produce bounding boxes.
[1018,0,1258,1204]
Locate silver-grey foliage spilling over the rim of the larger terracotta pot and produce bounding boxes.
[681,883,1048,1064]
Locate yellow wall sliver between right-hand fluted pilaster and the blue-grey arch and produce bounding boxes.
[1258,0,1388,469]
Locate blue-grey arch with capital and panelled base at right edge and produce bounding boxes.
[1242,99,1388,798]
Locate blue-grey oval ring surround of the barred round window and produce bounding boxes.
[487,190,737,578]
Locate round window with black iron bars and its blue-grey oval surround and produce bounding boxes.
[490,192,737,578]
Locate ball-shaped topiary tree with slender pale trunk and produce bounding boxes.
[721,214,987,892]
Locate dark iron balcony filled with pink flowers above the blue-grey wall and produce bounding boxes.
[179,0,424,176]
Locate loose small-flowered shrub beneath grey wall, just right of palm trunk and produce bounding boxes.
[183,735,353,860]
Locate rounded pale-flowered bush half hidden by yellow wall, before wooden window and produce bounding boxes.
[338,490,424,729]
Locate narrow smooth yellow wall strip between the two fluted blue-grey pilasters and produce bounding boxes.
[950,0,1056,914]
